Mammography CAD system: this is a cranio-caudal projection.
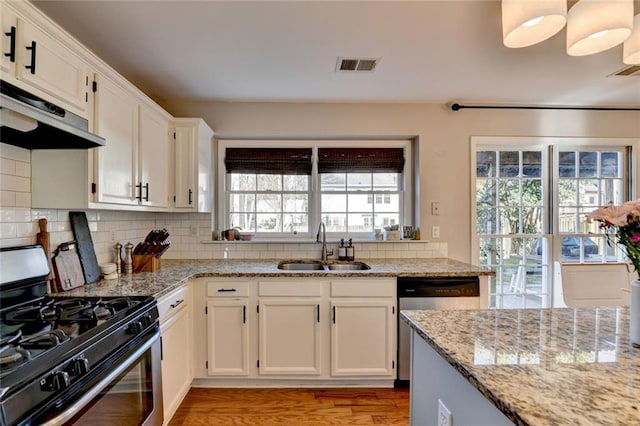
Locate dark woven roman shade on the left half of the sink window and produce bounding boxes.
[224,148,312,175]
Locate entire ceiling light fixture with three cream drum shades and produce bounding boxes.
[502,0,640,65]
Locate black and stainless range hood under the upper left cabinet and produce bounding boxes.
[0,81,105,149]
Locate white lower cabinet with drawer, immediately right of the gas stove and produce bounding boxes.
[158,284,193,424]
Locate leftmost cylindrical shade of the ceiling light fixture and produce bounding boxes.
[502,0,567,47]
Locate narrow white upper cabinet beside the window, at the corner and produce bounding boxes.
[173,118,213,213]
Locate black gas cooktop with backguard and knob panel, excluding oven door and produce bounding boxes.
[0,246,159,425]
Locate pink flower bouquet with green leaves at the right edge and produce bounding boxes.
[587,199,640,278]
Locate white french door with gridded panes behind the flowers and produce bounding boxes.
[472,137,630,308]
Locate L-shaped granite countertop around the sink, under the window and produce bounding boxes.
[53,258,494,298]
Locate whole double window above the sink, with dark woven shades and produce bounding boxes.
[217,141,413,238]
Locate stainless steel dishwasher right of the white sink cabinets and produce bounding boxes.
[395,277,480,387]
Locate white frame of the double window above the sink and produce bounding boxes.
[218,138,418,241]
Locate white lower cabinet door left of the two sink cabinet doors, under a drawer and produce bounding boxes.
[207,300,249,376]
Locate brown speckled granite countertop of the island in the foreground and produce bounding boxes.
[401,308,640,426]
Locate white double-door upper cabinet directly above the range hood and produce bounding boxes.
[1,2,91,119]
